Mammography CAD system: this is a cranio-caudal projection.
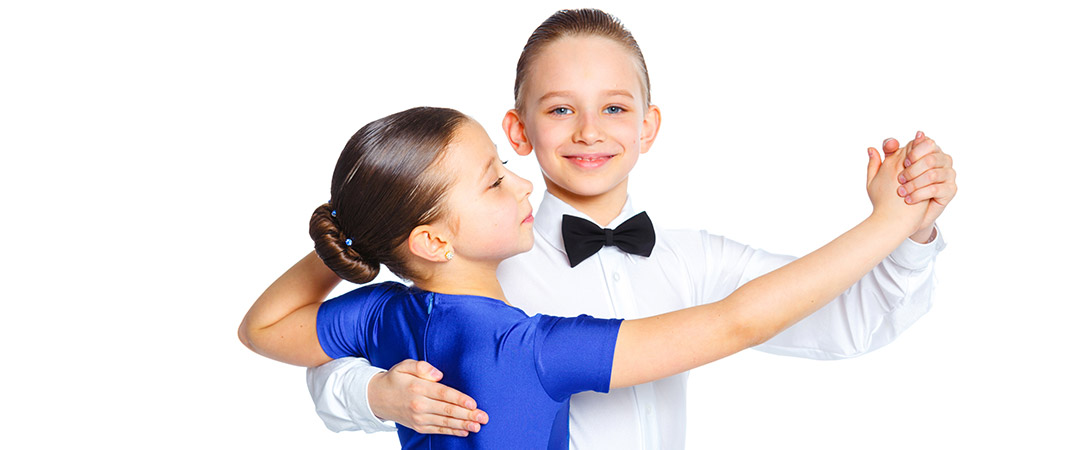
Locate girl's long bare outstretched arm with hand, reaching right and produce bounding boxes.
[610,142,927,388]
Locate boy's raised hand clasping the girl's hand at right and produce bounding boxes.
[881,132,957,243]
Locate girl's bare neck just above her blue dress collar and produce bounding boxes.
[413,258,510,304]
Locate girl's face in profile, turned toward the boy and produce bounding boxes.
[442,121,532,262]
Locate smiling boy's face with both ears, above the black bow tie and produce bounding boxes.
[504,37,660,205]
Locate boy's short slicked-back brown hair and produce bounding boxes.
[514,9,652,111]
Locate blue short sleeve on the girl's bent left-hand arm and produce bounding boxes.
[315,284,397,358]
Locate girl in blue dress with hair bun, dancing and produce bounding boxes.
[240,104,927,449]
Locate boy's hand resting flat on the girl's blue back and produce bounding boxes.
[367,359,487,436]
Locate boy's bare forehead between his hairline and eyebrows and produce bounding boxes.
[524,36,644,101]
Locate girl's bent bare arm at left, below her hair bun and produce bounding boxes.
[239,251,341,367]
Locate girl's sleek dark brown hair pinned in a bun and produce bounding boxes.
[308,107,470,284]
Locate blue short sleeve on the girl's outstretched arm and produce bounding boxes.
[536,315,622,401]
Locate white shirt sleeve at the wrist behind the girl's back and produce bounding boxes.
[308,357,397,433]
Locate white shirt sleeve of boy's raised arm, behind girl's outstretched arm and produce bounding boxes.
[703,226,945,359]
